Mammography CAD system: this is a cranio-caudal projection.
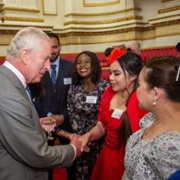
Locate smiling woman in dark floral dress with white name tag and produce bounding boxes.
[57,51,109,180]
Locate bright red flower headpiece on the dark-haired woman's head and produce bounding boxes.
[106,47,127,64]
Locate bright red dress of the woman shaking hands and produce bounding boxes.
[91,86,147,180]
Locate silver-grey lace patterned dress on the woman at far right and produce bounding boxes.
[125,113,180,180]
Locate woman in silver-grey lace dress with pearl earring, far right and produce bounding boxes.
[125,56,180,180]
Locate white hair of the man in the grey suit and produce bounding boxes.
[6,27,49,60]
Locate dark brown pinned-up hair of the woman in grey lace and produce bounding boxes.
[144,56,180,102]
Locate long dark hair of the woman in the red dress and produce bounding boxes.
[106,46,143,149]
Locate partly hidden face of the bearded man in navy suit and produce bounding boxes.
[50,37,61,62]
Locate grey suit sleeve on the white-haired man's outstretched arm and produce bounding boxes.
[0,89,75,168]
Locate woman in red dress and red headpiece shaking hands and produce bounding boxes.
[79,47,146,180]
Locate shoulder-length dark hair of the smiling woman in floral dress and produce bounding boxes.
[72,51,101,85]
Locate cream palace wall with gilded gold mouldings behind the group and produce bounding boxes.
[0,0,180,57]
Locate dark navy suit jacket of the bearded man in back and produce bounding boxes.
[38,58,74,144]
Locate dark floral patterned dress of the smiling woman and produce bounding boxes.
[67,79,109,180]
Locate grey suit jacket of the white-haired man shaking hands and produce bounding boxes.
[0,65,74,180]
